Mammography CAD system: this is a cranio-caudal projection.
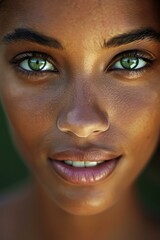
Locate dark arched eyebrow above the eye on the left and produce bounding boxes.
[2,28,63,49]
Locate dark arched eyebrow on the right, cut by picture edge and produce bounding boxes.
[103,28,160,47]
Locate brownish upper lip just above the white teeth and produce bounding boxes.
[49,148,121,162]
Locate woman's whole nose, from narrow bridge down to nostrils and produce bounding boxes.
[57,78,109,137]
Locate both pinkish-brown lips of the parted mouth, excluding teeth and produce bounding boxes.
[48,149,122,185]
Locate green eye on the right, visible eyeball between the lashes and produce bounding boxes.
[112,57,147,70]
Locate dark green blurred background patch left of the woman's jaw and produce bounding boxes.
[0,102,29,192]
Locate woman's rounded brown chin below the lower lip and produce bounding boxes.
[35,170,122,216]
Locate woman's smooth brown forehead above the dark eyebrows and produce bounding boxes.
[1,0,159,45]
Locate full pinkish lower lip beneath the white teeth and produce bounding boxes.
[49,157,120,184]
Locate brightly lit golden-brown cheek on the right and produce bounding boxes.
[112,85,160,170]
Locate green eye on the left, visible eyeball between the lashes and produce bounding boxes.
[19,57,57,72]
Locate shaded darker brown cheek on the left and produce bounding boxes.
[2,81,61,157]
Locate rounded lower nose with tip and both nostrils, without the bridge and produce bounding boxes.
[57,95,109,138]
